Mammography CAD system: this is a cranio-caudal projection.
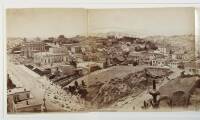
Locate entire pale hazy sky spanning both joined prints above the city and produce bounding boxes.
[7,8,194,37]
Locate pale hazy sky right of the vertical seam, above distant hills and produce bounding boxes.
[88,8,195,35]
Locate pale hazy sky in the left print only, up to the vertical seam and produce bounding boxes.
[7,8,87,37]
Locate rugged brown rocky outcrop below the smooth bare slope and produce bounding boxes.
[92,70,168,108]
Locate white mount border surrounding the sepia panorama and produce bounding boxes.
[0,0,200,120]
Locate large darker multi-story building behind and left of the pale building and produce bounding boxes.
[21,41,45,58]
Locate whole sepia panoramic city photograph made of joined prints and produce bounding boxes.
[5,7,200,114]
